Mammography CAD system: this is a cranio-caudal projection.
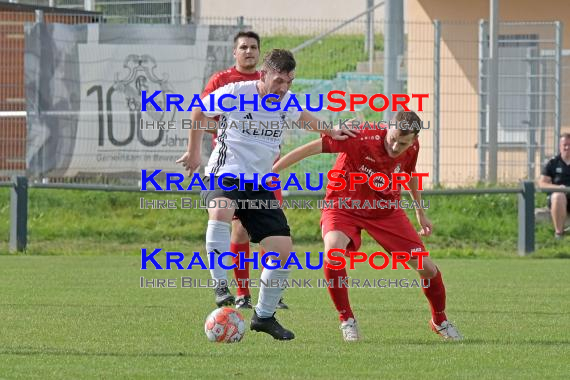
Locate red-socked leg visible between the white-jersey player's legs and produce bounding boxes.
[230,219,252,309]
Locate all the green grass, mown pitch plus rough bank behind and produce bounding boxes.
[0,189,570,379]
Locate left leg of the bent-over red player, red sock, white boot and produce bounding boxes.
[324,231,362,342]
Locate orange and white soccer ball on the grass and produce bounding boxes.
[204,307,245,343]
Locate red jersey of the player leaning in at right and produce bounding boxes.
[322,128,420,217]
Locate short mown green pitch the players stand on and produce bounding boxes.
[0,256,570,379]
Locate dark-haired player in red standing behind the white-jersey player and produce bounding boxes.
[200,31,288,309]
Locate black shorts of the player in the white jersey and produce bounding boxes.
[200,177,291,243]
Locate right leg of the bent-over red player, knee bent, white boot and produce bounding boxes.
[408,257,463,340]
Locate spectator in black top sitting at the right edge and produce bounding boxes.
[538,133,570,239]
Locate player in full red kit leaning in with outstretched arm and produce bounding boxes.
[273,111,462,342]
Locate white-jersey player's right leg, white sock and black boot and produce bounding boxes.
[250,236,295,340]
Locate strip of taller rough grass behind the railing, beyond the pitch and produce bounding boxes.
[0,189,570,258]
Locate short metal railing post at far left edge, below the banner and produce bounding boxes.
[10,176,28,252]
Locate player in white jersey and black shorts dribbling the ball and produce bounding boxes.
[177,49,356,340]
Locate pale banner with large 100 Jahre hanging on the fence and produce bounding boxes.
[26,24,239,176]
